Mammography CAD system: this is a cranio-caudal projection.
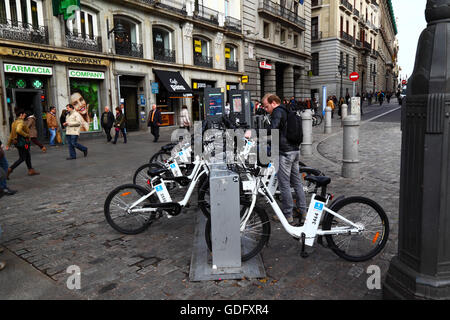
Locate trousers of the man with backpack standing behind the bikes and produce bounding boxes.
[278,151,307,217]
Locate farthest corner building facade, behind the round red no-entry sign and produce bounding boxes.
[311,0,398,102]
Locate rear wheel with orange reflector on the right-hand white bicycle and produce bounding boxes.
[323,197,389,262]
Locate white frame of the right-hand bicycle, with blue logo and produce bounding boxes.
[240,177,364,247]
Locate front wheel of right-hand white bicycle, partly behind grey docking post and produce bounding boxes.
[205,202,270,261]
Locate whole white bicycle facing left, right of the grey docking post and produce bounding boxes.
[205,168,389,262]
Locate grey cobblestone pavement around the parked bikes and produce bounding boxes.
[0,102,401,300]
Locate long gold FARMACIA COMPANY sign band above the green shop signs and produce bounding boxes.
[0,47,109,66]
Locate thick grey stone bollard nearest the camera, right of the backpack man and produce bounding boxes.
[342,115,360,178]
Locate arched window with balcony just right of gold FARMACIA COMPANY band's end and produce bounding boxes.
[114,16,143,58]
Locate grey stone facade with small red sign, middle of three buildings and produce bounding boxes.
[242,0,311,100]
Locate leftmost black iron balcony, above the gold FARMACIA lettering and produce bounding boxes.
[0,19,49,44]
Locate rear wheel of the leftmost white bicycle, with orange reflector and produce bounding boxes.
[104,184,157,234]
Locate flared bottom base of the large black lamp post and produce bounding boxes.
[383,257,450,300]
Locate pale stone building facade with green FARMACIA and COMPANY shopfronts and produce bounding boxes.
[0,0,244,141]
